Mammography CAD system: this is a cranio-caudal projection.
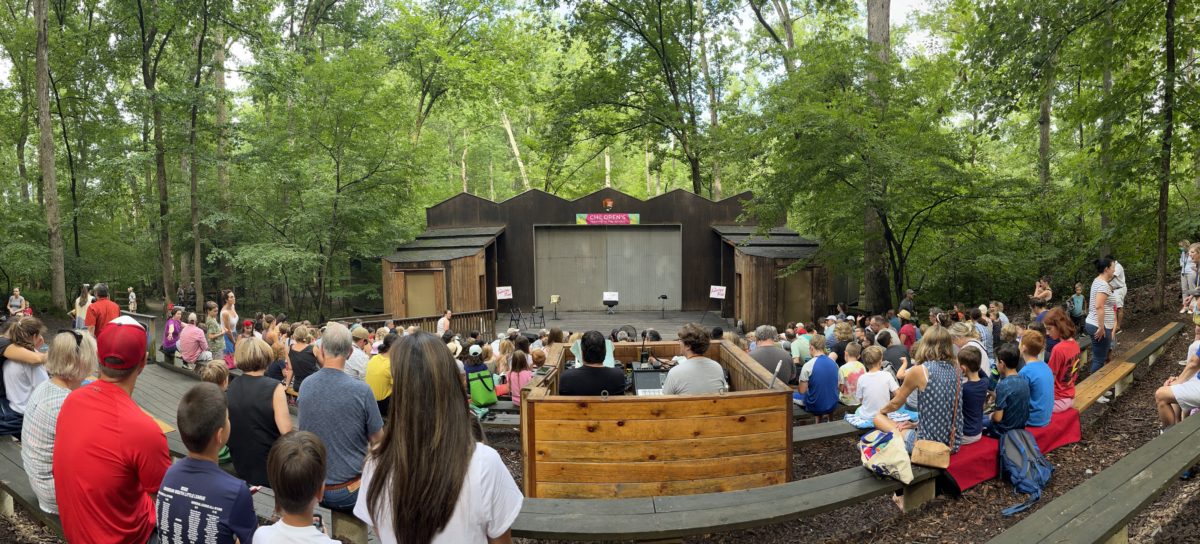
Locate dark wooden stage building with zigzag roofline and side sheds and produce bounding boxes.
[383,189,833,327]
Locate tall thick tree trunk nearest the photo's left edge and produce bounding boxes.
[34,0,67,310]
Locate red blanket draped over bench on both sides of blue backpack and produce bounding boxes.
[947,408,1081,491]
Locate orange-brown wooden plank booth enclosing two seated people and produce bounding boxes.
[520,341,792,498]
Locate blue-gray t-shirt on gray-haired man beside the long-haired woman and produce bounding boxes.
[296,369,383,485]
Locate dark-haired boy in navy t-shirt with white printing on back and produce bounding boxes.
[155,381,260,544]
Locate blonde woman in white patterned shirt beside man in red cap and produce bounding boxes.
[20,331,97,514]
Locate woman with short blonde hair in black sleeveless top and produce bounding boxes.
[225,339,292,485]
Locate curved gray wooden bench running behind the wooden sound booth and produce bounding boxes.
[512,461,940,540]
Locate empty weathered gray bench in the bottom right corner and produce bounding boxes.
[990,401,1200,544]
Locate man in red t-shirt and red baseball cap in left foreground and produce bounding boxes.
[53,317,170,544]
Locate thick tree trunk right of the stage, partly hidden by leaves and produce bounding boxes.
[862,0,892,312]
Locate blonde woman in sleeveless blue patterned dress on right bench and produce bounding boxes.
[875,326,973,453]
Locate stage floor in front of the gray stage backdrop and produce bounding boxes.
[496,306,732,340]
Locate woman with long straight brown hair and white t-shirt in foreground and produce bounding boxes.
[354,333,523,544]
